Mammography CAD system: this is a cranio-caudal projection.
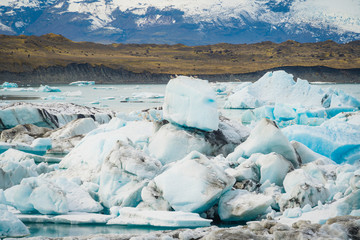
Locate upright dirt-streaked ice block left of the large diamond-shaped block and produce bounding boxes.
[98,141,162,208]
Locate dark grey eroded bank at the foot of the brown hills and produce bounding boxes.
[0,63,360,85]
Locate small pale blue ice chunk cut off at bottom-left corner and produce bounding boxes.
[0,204,30,238]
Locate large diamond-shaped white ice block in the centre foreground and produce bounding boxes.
[154,151,235,213]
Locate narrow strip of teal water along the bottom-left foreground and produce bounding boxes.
[26,223,169,238]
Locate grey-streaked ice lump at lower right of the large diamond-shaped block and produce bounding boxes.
[218,189,273,221]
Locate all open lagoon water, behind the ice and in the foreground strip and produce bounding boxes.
[0,83,360,237]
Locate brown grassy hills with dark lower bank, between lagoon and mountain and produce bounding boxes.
[0,34,360,84]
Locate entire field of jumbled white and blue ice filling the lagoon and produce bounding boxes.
[0,71,360,237]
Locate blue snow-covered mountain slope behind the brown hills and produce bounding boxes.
[0,0,360,45]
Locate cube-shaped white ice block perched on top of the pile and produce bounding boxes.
[163,76,219,131]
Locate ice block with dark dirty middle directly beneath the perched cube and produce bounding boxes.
[148,118,250,164]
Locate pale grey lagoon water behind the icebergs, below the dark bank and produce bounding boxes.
[0,83,360,115]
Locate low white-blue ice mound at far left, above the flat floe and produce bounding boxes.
[4,175,103,214]
